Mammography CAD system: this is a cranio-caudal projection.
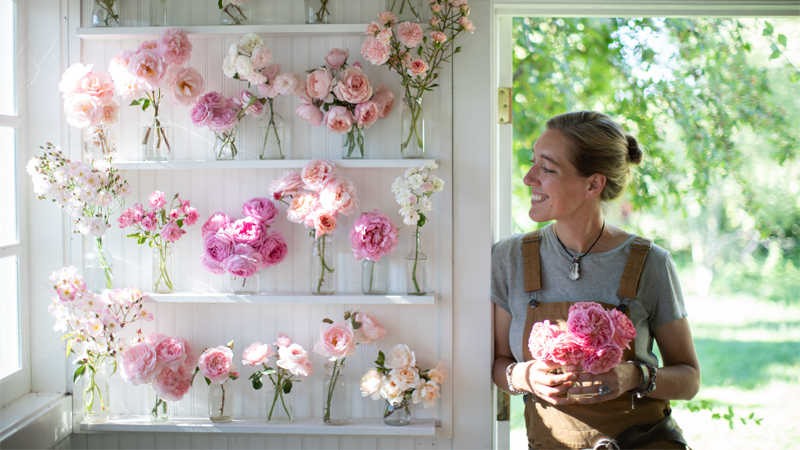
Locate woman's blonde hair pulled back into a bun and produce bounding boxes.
[547,111,642,201]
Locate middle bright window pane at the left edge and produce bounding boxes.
[0,126,18,246]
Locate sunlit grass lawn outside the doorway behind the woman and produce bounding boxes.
[511,296,800,450]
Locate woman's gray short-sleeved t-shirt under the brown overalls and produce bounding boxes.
[492,225,687,365]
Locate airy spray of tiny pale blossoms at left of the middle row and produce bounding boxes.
[25,144,133,237]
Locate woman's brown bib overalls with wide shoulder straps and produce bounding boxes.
[522,230,686,449]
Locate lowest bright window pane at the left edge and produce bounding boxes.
[0,256,21,378]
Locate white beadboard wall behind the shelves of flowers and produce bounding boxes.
[68,0,453,449]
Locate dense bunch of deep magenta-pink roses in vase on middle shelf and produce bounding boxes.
[201,198,287,293]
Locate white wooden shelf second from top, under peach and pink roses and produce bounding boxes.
[113,159,434,170]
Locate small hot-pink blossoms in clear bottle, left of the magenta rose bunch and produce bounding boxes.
[117,191,200,294]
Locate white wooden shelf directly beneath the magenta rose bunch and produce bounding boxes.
[148,292,436,305]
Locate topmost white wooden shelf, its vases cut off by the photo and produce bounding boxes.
[77,23,367,40]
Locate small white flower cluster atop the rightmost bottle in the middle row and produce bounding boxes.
[392,161,444,227]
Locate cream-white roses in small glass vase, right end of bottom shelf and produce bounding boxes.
[242,333,314,423]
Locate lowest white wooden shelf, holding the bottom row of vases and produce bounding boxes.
[80,416,436,436]
